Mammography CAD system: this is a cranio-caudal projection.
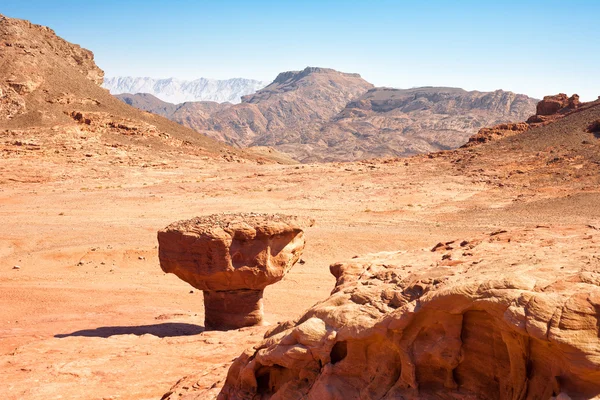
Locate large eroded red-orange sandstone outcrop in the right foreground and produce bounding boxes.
[219,227,600,400]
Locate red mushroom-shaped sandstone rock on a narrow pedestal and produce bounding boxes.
[158,213,313,330]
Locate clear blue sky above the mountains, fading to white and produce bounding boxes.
[0,0,600,100]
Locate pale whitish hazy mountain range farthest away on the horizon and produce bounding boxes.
[102,76,268,104]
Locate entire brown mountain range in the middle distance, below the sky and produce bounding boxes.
[117,67,538,163]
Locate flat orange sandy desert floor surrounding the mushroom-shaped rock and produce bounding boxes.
[0,152,600,399]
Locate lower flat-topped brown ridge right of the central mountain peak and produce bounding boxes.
[303,87,537,161]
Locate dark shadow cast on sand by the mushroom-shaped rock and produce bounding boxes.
[54,322,204,338]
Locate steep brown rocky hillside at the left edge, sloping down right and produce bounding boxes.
[0,16,274,170]
